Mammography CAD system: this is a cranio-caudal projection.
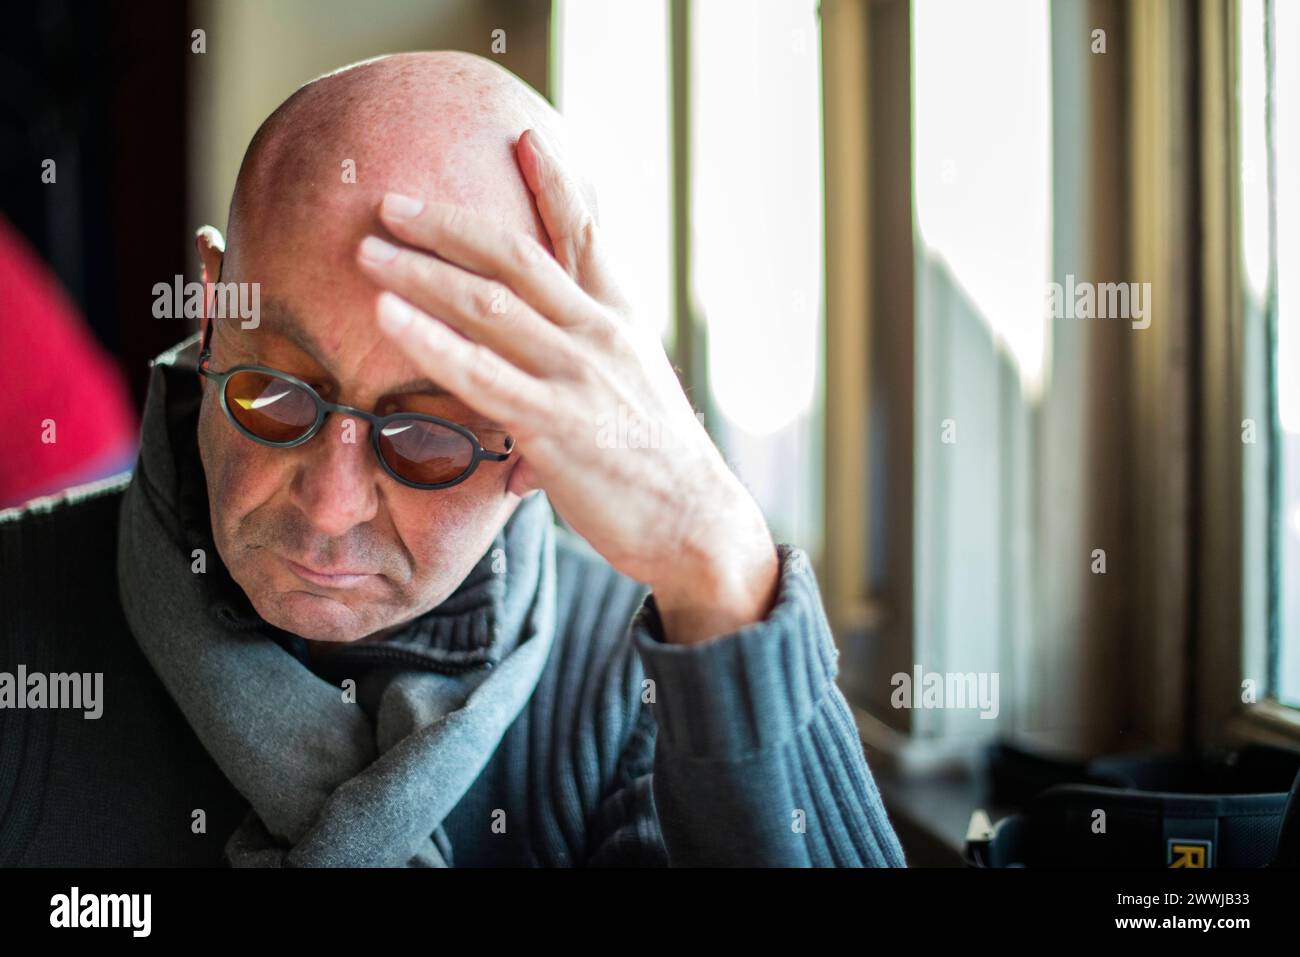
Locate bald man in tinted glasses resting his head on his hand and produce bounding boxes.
[0,53,904,867]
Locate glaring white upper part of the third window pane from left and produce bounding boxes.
[913,0,1052,395]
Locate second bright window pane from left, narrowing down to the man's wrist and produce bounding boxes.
[692,0,822,553]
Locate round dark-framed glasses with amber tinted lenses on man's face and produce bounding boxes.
[199,347,515,489]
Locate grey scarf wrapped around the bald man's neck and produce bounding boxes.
[117,338,555,867]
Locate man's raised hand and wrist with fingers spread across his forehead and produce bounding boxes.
[358,130,779,642]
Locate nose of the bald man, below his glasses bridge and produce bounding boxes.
[293,415,380,536]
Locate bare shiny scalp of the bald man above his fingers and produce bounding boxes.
[219,51,595,276]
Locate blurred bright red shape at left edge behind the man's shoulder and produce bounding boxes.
[0,218,137,507]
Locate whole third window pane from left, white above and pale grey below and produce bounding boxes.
[911,0,1053,736]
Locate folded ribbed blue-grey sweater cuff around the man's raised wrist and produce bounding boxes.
[631,545,839,759]
